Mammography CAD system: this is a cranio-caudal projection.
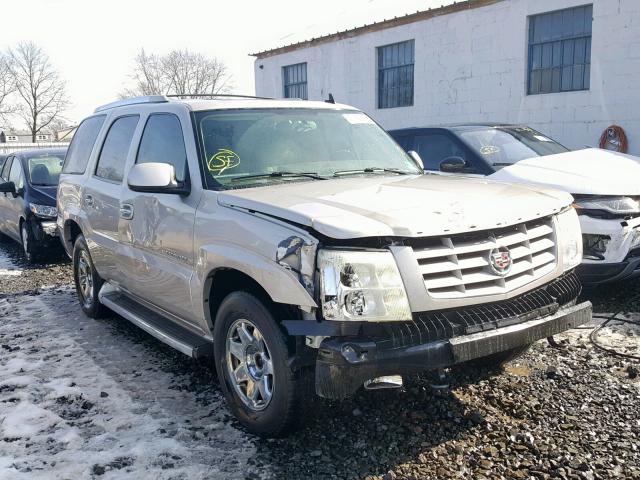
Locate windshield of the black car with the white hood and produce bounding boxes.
[458,127,569,170]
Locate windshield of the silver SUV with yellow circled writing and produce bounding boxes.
[196,108,422,188]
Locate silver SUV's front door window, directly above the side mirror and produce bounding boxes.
[136,113,187,182]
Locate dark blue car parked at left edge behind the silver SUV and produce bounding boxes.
[0,148,66,261]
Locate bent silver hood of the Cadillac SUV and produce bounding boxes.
[218,175,572,239]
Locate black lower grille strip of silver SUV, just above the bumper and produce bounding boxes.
[378,272,582,348]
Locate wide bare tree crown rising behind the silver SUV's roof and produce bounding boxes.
[121,49,231,97]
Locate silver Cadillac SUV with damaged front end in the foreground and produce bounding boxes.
[58,96,591,435]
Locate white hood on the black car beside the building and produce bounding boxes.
[489,148,640,195]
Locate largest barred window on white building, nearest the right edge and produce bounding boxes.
[528,5,593,95]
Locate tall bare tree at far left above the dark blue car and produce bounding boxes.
[8,42,69,142]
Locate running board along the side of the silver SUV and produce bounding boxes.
[100,291,213,358]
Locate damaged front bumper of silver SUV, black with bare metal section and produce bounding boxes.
[316,302,592,399]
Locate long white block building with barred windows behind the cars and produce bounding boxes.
[255,0,640,154]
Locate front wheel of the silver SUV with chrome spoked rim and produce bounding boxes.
[214,292,314,437]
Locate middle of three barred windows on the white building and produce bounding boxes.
[378,40,415,108]
